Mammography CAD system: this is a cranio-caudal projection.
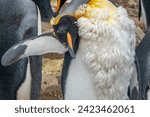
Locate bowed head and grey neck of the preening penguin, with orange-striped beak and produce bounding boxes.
[50,0,89,58]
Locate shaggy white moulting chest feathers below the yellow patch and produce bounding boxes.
[77,7,136,99]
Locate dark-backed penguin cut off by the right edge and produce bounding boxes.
[136,0,150,100]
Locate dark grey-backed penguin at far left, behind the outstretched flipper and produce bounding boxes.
[0,0,41,100]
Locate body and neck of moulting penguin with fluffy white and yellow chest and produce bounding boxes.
[52,0,137,100]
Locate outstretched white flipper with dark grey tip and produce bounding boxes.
[1,33,67,66]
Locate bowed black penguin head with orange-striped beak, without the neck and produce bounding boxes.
[53,15,78,58]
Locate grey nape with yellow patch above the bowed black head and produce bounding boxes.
[50,0,89,25]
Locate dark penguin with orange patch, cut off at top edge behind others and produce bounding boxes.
[32,0,66,22]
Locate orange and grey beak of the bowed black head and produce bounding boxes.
[67,32,75,59]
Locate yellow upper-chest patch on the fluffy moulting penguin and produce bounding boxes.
[74,0,117,21]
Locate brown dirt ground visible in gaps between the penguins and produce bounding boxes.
[40,0,144,100]
